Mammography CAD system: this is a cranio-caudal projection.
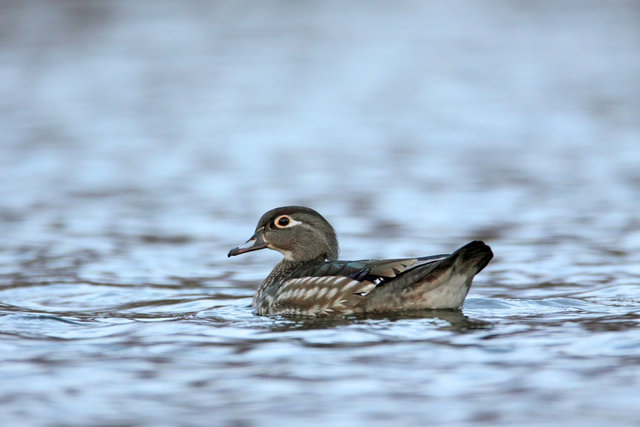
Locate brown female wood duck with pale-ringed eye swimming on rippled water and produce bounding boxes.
[228,206,493,316]
